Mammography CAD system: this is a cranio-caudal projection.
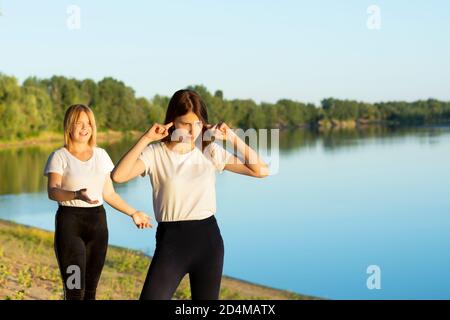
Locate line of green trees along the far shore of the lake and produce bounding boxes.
[0,74,450,140]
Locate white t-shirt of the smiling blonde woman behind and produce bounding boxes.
[44,147,114,207]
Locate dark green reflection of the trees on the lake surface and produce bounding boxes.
[0,126,450,194]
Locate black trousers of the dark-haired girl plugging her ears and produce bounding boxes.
[140,216,224,300]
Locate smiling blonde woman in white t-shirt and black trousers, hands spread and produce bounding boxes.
[44,104,151,300]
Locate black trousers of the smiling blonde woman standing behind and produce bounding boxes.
[55,206,108,300]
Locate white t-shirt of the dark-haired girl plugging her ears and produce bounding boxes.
[139,141,232,222]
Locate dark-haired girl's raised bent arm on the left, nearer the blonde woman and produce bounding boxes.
[111,122,172,183]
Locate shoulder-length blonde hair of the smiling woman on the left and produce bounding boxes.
[64,104,97,148]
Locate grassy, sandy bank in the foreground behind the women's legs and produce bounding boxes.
[0,220,311,300]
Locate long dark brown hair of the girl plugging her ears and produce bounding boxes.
[161,89,211,151]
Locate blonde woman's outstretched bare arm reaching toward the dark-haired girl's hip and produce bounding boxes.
[103,176,152,229]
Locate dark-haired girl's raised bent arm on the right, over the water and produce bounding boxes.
[209,123,269,178]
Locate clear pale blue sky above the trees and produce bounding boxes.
[0,0,450,103]
